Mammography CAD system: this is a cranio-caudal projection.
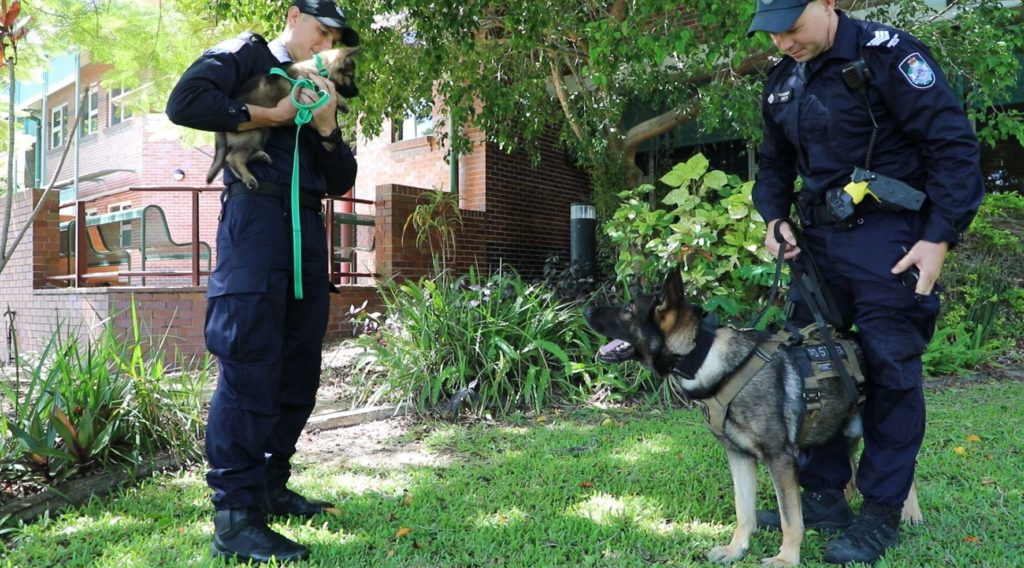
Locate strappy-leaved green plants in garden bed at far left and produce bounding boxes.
[0,306,206,483]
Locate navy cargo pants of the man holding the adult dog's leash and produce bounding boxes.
[794,212,939,507]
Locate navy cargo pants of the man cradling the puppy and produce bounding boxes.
[200,194,330,510]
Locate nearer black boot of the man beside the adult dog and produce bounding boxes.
[825,501,903,564]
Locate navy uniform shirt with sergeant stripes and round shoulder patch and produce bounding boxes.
[753,10,984,245]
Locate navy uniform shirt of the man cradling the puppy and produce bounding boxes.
[167,33,356,195]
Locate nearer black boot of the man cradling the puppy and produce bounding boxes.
[210,509,309,564]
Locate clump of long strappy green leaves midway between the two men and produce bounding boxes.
[354,270,629,412]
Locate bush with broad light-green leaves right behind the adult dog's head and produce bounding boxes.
[603,154,774,317]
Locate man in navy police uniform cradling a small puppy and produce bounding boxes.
[167,0,358,562]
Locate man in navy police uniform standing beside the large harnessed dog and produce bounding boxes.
[749,0,984,564]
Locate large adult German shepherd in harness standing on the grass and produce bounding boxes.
[585,270,922,566]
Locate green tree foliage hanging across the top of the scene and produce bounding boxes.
[18,0,1024,205]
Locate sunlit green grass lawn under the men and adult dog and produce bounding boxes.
[0,382,1024,568]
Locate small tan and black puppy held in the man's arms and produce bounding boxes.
[206,47,359,189]
